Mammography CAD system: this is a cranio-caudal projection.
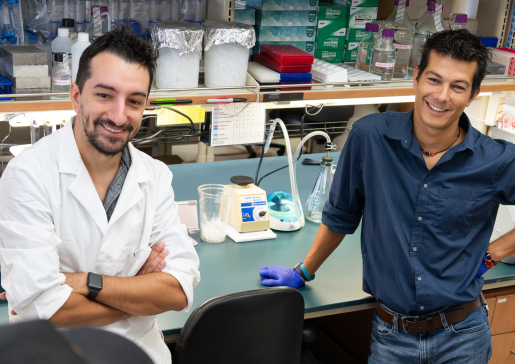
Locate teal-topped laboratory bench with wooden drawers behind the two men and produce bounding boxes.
[0,153,515,363]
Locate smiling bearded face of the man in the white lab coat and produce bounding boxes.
[74,52,150,155]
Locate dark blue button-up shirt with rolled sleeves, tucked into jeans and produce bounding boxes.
[322,112,515,315]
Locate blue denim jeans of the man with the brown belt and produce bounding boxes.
[368,305,492,364]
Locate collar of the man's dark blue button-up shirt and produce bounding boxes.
[385,110,481,152]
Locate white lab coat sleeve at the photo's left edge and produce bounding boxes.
[0,160,72,321]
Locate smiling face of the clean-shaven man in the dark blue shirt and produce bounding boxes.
[413,51,479,129]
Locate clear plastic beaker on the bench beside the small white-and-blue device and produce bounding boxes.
[198,184,233,243]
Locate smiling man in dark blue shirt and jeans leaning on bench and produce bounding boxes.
[260,30,515,364]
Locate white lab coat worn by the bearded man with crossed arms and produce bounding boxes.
[0,118,200,364]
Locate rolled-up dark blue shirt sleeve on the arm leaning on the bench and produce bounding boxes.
[322,123,365,234]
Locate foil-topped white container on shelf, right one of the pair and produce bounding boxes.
[203,21,256,87]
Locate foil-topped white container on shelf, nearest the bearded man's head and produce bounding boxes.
[152,21,204,89]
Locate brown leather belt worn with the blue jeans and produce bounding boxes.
[377,297,481,334]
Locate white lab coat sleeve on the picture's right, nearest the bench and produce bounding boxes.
[150,164,200,312]
